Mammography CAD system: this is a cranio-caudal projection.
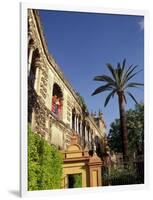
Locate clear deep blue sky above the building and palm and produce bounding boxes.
[40,10,144,131]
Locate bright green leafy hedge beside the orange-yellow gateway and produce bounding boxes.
[28,127,62,190]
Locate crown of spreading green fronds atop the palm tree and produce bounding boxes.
[92,59,143,106]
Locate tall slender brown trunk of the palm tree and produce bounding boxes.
[118,92,128,162]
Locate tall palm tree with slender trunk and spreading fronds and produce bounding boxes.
[92,59,143,162]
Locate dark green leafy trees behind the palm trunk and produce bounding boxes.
[108,103,144,155]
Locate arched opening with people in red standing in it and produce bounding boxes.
[52,83,63,119]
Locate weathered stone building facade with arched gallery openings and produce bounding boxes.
[28,9,106,155]
